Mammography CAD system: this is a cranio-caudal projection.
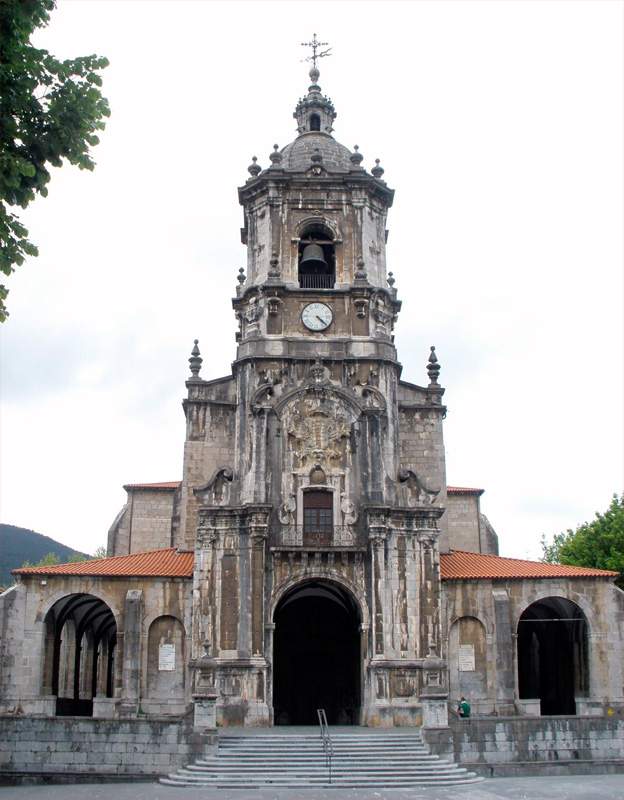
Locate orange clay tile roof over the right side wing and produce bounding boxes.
[440,550,619,581]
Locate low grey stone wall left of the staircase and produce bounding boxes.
[0,716,216,783]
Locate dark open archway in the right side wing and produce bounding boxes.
[518,597,589,714]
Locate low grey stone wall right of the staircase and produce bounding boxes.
[423,715,624,777]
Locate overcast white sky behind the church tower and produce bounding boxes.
[0,0,624,557]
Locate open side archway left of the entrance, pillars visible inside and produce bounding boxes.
[43,594,117,716]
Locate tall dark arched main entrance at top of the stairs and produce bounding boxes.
[273,580,360,725]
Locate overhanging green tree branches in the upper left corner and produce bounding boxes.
[0,0,110,322]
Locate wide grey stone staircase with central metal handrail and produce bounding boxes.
[160,728,483,789]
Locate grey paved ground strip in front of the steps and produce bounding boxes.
[0,774,624,800]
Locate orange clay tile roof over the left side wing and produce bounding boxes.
[12,547,194,578]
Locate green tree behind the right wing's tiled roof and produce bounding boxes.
[541,494,624,589]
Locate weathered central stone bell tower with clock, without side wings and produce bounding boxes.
[179,59,447,725]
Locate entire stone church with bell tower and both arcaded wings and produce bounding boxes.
[0,67,624,744]
